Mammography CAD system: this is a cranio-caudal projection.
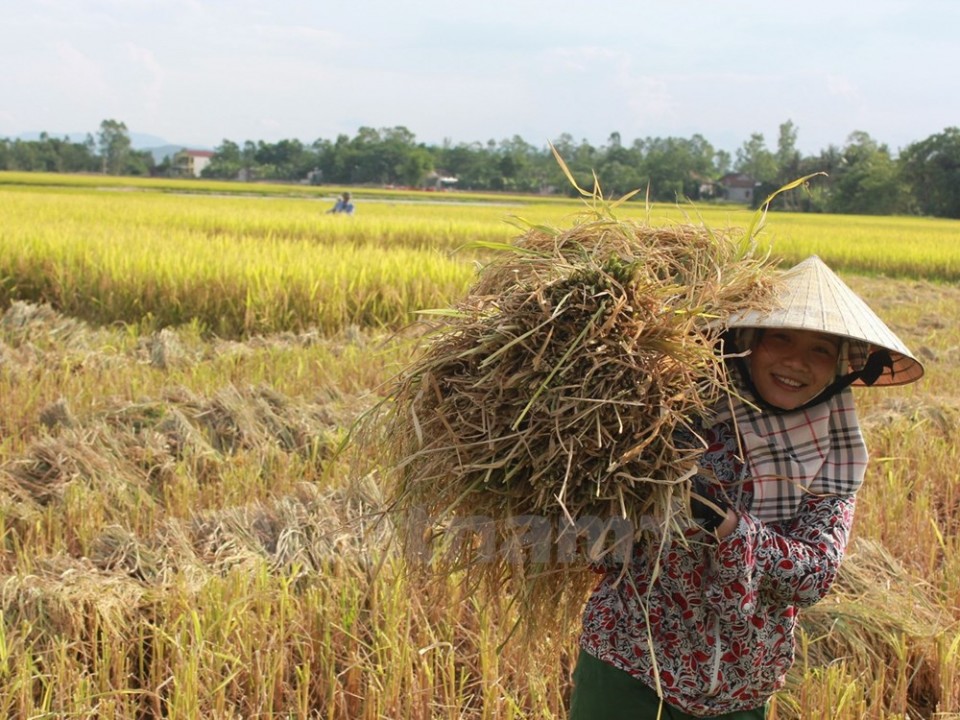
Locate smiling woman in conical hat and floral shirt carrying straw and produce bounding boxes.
[570,256,923,720]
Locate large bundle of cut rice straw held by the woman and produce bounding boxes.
[382,204,772,612]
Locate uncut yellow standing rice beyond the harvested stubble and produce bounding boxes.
[0,177,960,337]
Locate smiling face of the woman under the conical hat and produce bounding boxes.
[748,328,840,410]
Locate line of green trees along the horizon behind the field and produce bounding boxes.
[0,119,960,218]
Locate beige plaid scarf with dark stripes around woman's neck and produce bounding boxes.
[716,388,867,522]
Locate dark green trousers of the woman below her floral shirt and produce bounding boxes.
[569,650,766,720]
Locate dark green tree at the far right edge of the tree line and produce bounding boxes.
[899,127,960,218]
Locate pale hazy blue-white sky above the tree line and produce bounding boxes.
[0,0,960,155]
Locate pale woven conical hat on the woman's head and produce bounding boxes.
[727,255,923,385]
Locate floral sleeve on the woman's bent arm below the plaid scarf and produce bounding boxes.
[717,495,856,607]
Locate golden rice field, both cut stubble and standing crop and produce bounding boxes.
[0,173,960,720]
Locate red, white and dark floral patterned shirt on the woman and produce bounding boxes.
[580,390,866,716]
